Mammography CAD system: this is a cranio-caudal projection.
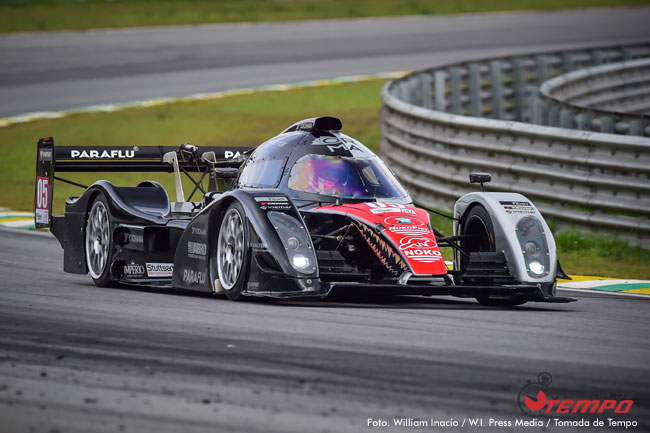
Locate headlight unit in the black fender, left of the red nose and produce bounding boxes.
[267,211,317,274]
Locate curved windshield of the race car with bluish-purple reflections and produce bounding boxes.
[287,154,407,199]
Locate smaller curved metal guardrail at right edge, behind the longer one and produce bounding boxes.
[532,58,650,137]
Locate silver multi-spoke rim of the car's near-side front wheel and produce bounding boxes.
[217,209,244,290]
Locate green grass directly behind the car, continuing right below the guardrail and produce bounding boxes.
[0,80,650,279]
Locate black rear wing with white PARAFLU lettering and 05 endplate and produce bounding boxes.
[34,137,251,228]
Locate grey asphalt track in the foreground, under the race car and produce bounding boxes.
[0,229,650,433]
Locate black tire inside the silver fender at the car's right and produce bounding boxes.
[461,205,527,307]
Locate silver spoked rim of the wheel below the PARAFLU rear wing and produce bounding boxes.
[86,202,109,279]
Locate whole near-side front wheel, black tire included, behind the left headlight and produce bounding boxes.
[216,202,250,301]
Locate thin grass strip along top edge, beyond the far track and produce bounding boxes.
[0,0,648,32]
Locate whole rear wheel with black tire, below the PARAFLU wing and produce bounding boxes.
[84,193,115,287]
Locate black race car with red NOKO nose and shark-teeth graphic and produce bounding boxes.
[34,117,571,305]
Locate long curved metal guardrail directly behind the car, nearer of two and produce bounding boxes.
[381,43,650,244]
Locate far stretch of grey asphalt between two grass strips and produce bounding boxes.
[0,8,650,117]
